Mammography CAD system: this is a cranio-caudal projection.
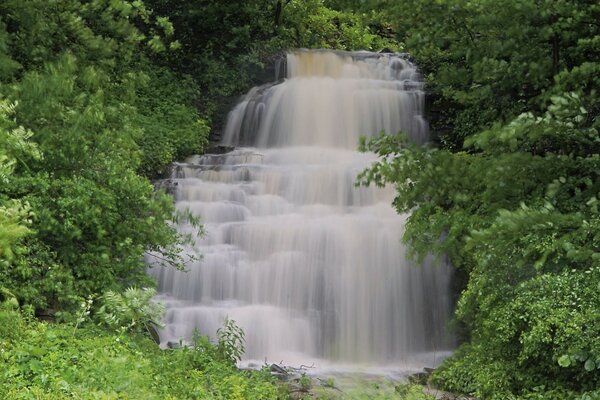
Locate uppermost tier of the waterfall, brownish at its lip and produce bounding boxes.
[224,51,427,150]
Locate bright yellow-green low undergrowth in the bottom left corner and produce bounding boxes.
[0,307,285,400]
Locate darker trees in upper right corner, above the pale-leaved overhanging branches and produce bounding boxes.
[370,0,600,151]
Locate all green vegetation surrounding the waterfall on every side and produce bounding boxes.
[0,0,600,399]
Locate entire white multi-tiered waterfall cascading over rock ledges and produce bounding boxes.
[149,51,451,372]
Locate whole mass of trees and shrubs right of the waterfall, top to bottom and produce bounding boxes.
[361,0,600,399]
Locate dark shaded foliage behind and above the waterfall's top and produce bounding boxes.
[146,0,398,125]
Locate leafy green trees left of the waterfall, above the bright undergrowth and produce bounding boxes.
[0,0,208,317]
